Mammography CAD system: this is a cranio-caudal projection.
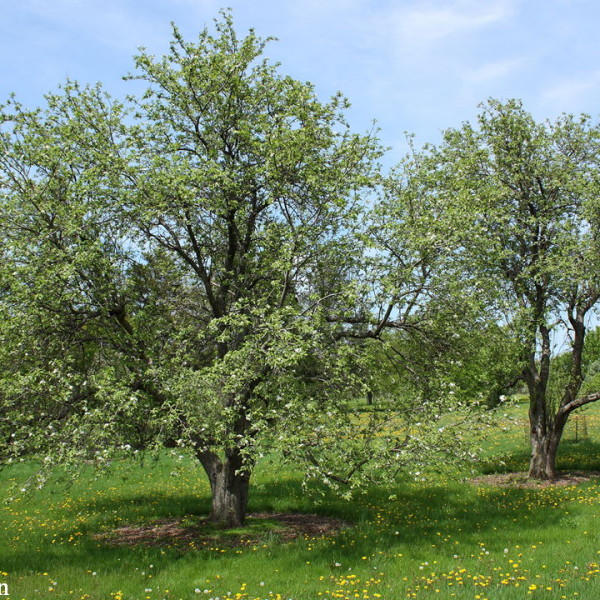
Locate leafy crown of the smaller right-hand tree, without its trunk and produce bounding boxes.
[434,101,598,323]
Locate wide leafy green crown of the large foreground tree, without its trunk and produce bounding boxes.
[0,12,486,502]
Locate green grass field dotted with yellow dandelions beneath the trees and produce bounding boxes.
[0,398,600,600]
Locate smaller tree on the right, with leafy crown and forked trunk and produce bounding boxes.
[422,100,600,478]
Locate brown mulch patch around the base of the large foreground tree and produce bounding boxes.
[94,513,350,550]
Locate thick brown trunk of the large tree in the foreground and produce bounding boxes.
[198,450,250,529]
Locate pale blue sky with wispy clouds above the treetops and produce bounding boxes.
[0,0,600,162]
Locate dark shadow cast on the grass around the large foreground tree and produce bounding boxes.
[3,466,588,573]
